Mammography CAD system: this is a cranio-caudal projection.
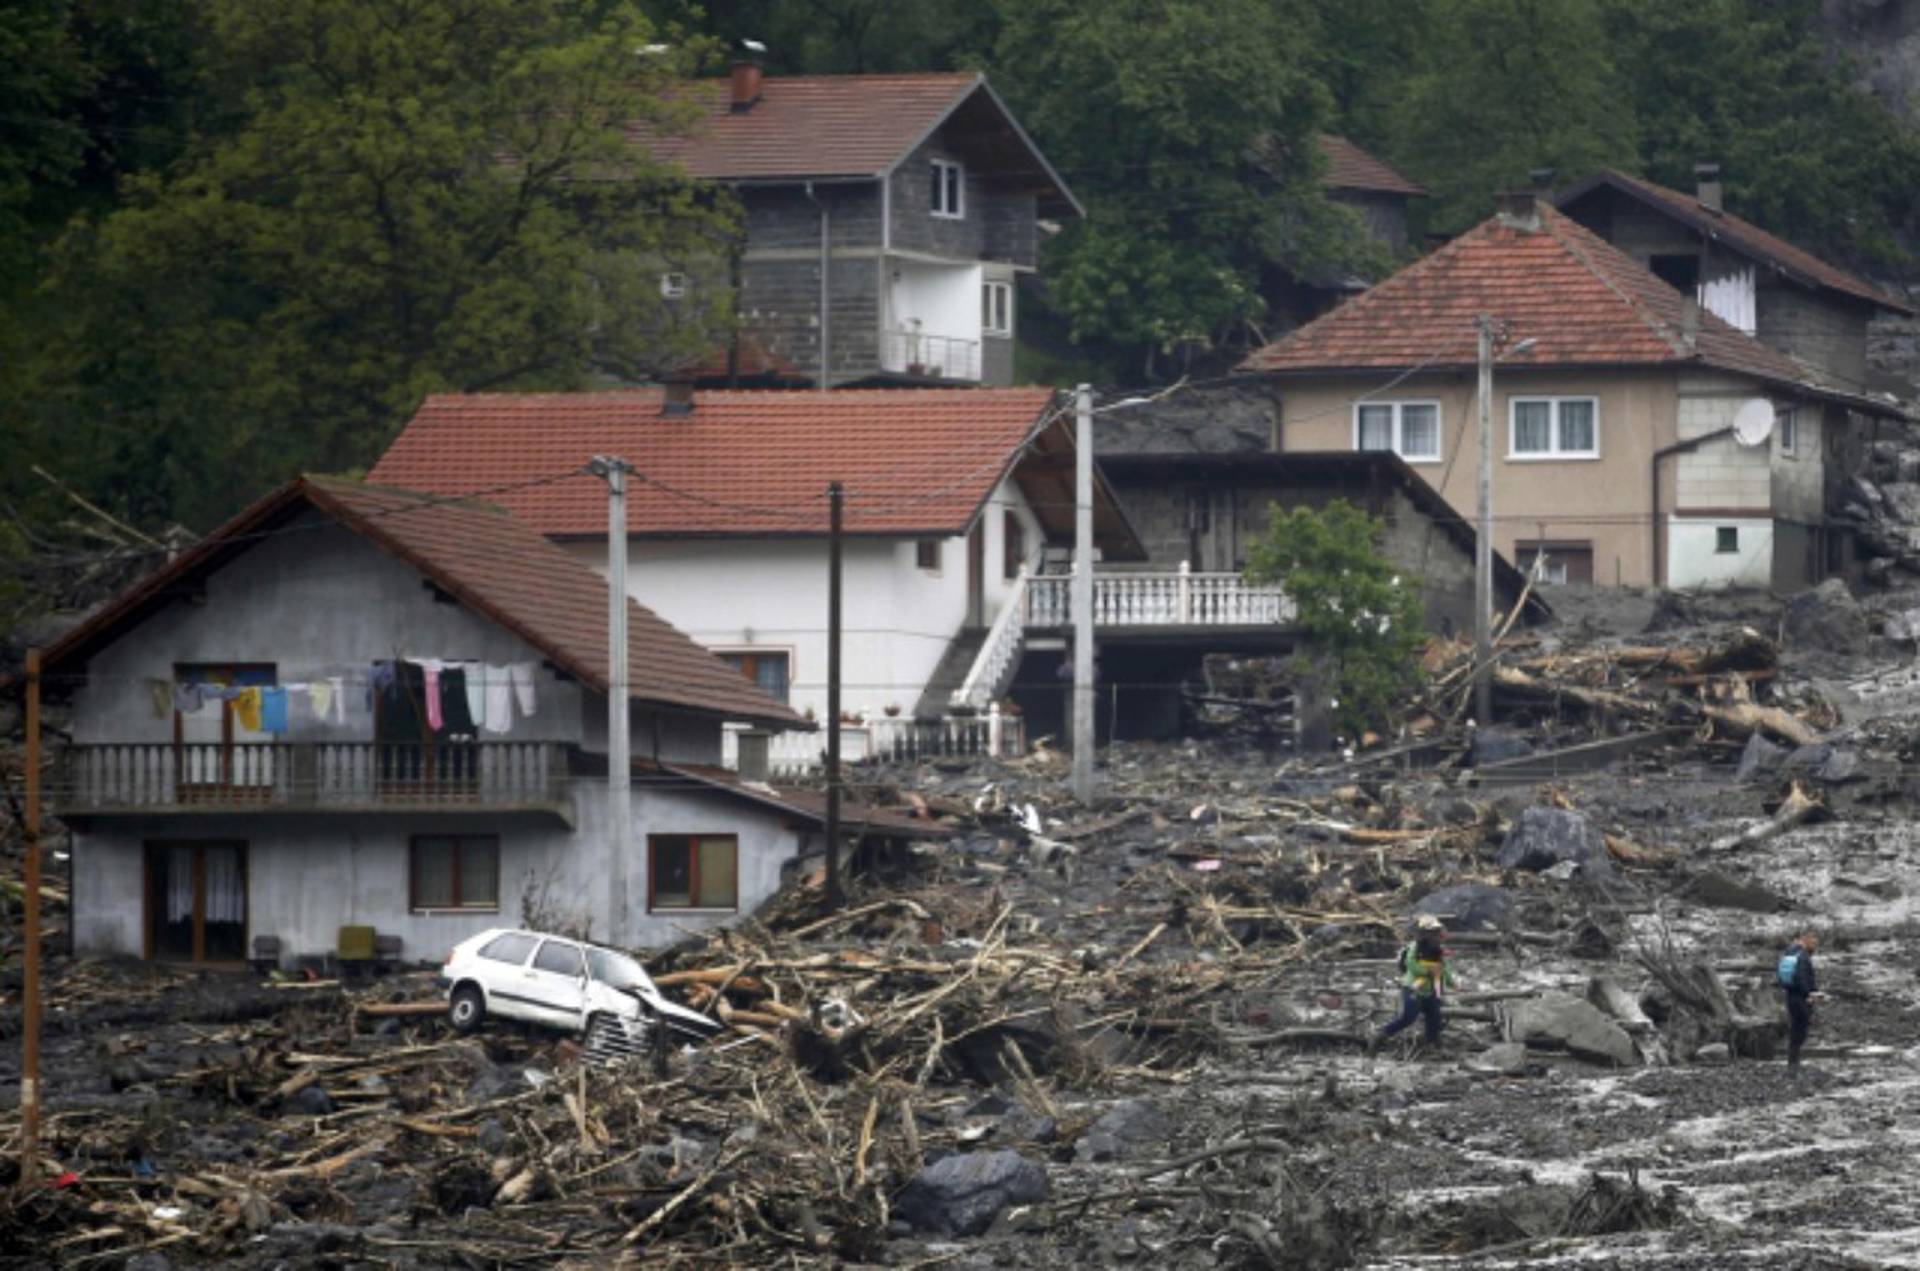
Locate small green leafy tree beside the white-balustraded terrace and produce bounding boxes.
[1246,499,1427,735]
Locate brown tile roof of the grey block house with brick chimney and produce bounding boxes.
[628,73,1079,215]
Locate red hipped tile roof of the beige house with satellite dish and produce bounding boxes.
[1240,196,1807,384]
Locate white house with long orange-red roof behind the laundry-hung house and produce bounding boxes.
[372,386,1140,753]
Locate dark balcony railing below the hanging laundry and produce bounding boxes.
[48,741,566,814]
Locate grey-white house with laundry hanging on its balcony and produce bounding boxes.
[30,478,929,962]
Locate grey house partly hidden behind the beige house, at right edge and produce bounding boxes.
[1555,165,1914,394]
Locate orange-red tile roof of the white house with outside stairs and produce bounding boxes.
[369,388,1139,555]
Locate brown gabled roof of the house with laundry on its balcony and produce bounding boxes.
[46,476,801,728]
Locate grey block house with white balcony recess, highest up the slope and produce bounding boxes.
[634,61,1083,388]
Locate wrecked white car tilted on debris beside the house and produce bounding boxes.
[440,927,722,1056]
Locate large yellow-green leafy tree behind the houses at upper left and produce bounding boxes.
[40,0,733,524]
